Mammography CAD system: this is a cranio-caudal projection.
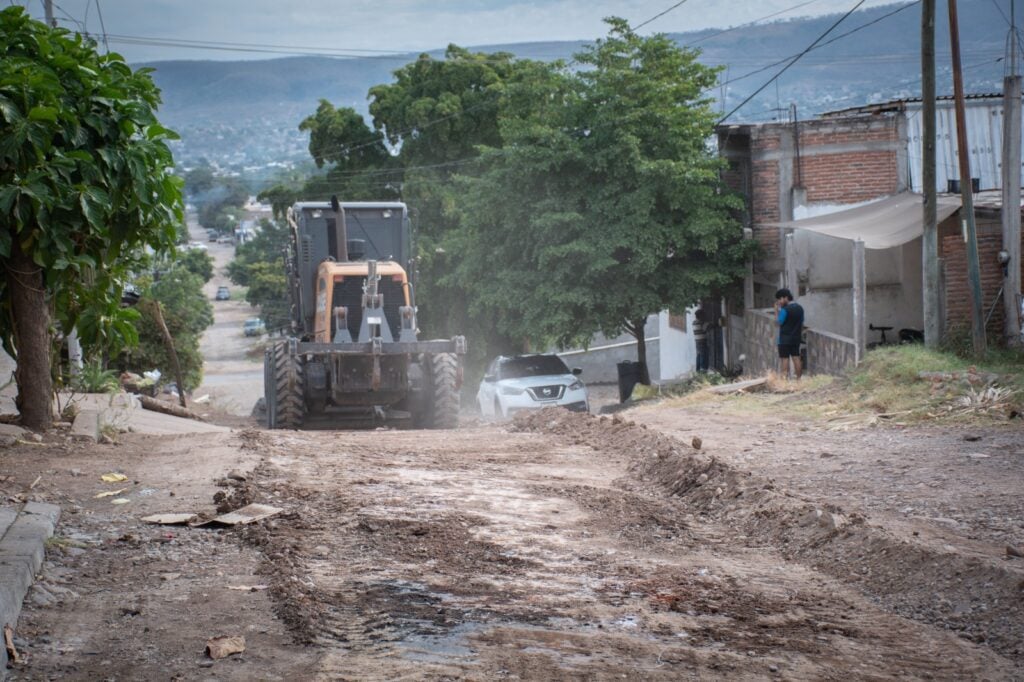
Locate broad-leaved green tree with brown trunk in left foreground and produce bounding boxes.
[0,6,182,428]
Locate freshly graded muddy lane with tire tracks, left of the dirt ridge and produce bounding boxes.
[230,421,1011,680]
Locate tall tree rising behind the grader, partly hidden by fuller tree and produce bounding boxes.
[370,45,551,337]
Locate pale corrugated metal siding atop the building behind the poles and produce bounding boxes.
[905,98,1011,193]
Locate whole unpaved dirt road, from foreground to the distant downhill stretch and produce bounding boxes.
[0,218,1024,680]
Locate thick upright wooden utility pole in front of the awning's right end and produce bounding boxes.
[921,0,942,348]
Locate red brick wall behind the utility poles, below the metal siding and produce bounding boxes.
[941,226,1024,333]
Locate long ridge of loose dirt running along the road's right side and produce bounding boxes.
[512,409,1024,662]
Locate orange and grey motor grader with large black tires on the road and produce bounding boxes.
[263,197,466,429]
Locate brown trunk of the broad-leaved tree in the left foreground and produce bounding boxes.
[6,241,53,431]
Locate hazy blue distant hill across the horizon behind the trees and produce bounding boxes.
[146,0,1009,168]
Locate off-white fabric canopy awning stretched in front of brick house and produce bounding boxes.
[767,191,961,249]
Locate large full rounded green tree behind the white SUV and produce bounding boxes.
[445,18,749,378]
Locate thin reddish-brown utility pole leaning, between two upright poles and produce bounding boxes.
[949,0,986,356]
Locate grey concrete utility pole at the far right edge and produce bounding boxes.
[1000,0,1024,346]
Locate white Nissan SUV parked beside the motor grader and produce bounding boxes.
[476,354,590,419]
